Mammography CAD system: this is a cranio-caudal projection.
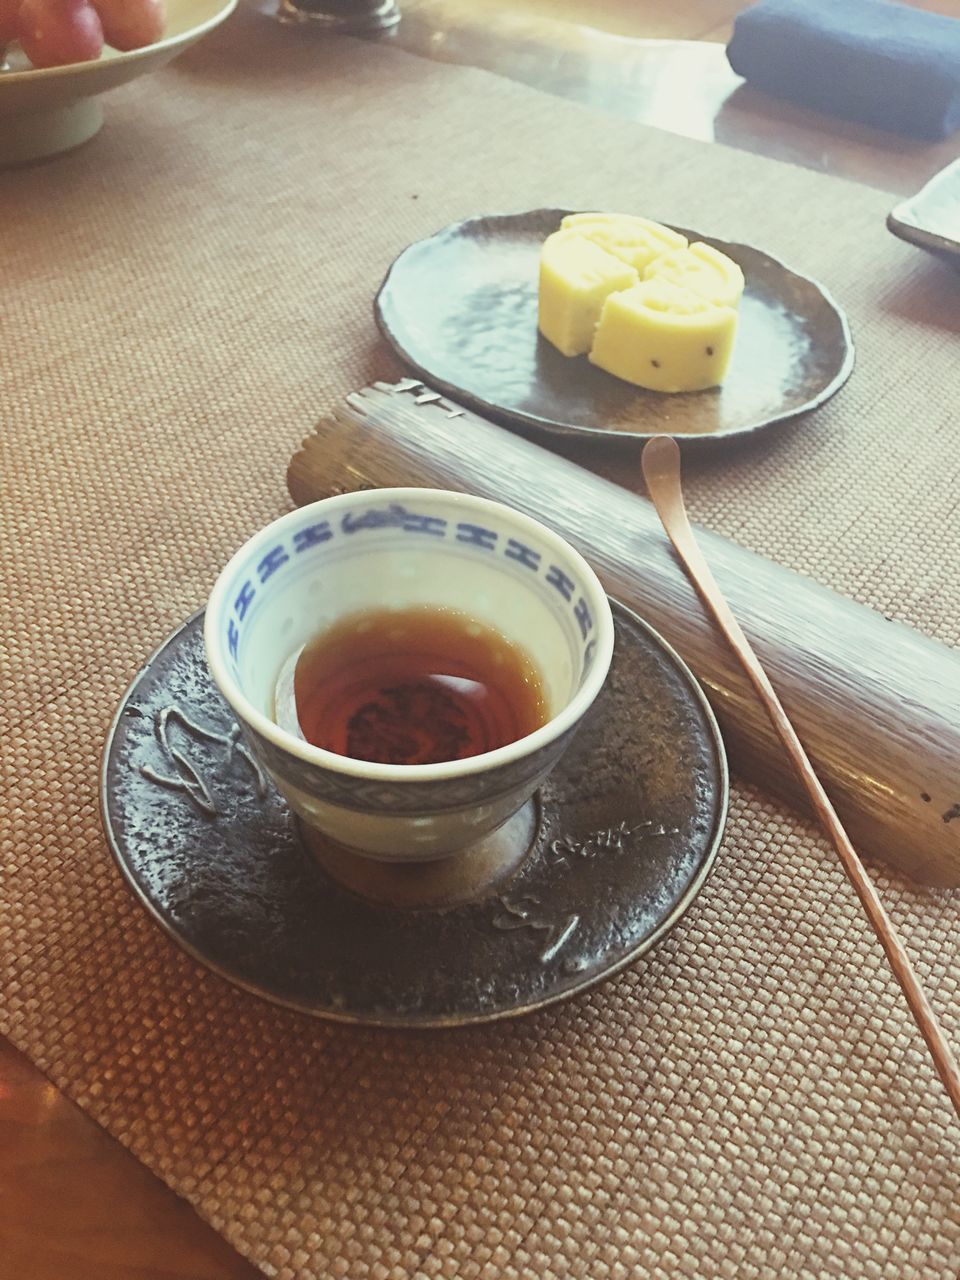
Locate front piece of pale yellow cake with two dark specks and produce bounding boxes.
[590,280,737,392]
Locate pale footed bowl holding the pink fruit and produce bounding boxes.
[0,0,237,165]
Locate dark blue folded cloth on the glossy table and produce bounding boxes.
[727,0,960,138]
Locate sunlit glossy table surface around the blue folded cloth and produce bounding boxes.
[393,0,960,204]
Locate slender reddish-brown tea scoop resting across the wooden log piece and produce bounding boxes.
[641,435,960,1117]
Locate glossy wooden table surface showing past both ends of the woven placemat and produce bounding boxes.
[0,0,960,1280]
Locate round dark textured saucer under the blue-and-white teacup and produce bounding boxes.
[101,604,727,1027]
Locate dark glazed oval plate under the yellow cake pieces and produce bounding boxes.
[375,209,854,439]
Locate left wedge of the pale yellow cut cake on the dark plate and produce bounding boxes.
[539,230,639,356]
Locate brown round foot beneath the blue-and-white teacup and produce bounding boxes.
[300,799,540,909]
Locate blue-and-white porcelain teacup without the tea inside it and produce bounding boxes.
[205,489,613,861]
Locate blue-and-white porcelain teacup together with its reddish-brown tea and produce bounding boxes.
[205,489,613,863]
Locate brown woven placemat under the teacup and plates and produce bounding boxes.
[0,15,960,1280]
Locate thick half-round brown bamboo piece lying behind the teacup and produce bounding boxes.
[287,378,960,886]
